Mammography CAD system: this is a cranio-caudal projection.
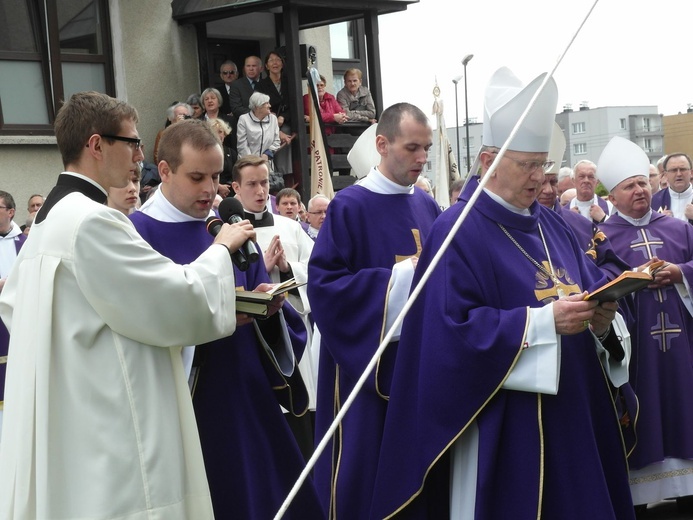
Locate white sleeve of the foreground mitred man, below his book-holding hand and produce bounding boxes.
[503,303,561,395]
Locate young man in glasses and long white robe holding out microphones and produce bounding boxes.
[0,92,255,520]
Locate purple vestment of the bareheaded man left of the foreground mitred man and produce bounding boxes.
[308,186,440,519]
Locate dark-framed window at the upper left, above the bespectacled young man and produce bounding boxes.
[0,0,115,135]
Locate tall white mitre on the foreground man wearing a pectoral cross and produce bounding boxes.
[482,67,558,152]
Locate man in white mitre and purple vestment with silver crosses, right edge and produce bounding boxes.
[599,137,693,513]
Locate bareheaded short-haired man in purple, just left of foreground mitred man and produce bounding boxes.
[308,103,440,519]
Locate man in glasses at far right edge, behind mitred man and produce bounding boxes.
[652,153,693,224]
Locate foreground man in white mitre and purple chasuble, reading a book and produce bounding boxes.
[370,68,634,520]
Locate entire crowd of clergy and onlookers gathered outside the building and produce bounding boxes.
[0,58,693,520]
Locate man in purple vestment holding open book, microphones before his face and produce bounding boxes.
[130,123,324,519]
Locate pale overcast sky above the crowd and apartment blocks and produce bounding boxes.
[379,0,693,127]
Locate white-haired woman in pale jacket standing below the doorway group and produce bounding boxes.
[237,92,281,164]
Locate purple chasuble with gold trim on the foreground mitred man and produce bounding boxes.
[371,185,634,520]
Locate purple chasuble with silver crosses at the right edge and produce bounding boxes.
[602,211,693,469]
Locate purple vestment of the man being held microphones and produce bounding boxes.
[130,212,324,519]
